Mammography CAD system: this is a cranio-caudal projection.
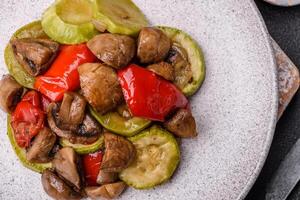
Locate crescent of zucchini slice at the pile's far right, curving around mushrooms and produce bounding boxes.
[158,26,205,96]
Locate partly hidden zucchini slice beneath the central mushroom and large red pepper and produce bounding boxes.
[90,108,151,137]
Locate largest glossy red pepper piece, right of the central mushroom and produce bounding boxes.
[118,64,188,121]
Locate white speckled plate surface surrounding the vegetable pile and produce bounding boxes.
[0,0,278,200]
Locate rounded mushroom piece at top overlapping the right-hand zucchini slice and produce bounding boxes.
[137,27,171,63]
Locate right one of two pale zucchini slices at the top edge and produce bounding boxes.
[95,0,148,36]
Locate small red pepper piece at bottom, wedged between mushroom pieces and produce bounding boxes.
[82,151,103,186]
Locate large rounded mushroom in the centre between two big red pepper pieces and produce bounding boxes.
[78,63,123,114]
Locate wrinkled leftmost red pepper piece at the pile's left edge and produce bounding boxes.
[11,91,45,148]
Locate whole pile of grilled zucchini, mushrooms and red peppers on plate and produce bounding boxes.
[0,0,205,199]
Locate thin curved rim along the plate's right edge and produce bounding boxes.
[237,0,279,200]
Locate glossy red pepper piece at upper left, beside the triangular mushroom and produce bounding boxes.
[34,44,97,102]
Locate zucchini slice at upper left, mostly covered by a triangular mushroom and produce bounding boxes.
[4,21,48,88]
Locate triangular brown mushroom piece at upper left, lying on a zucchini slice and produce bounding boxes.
[10,38,59,76]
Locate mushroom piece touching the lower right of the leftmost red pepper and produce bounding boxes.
[26,128,56,163]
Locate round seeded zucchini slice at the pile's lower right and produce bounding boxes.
[119,126,180,189]
